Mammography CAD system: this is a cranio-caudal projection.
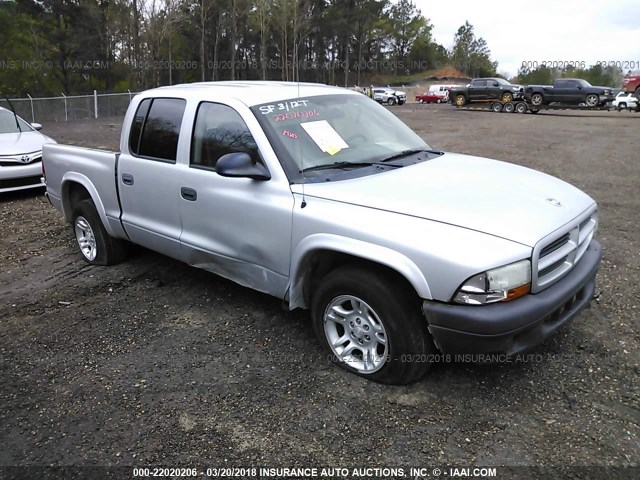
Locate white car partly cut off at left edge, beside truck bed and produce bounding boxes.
[0,107,56,193]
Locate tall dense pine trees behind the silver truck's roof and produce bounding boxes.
[0,0,497,96]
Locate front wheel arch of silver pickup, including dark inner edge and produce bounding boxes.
[287,234,432,309]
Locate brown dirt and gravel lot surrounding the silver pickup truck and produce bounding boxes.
[0,104,640,478]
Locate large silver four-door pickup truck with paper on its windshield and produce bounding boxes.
[44,82,601,384]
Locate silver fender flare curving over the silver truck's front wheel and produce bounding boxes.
[288,233,432,309]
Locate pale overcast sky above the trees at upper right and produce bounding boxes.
[413,0,640,75]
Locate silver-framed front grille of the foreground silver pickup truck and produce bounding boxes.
[531,209,598,293]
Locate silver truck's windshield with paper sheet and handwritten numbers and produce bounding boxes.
[251,95,431,181]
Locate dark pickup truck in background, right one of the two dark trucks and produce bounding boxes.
[524,78,613,107]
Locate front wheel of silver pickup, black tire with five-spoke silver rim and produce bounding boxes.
[311,266,435,385]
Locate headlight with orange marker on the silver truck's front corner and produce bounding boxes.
[453,260,531,305]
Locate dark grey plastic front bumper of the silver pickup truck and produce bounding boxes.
[422,240,602,355]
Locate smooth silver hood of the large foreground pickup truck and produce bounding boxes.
[292,153,594,247]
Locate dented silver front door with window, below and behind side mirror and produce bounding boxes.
[180,102,293,298]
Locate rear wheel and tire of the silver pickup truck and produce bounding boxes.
[71,199,127,265]
